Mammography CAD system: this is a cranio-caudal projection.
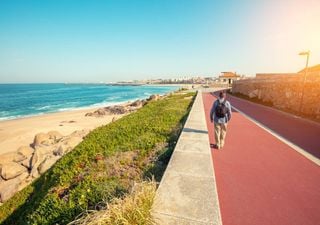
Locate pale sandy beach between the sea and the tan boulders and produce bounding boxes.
[0,107,122,154]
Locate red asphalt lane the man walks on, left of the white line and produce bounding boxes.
[203,93,320,225]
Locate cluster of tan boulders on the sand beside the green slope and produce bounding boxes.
[0,130,90,203]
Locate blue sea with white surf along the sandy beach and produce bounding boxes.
[0,84,179,120]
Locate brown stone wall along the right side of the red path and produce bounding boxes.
[232,75,320,119]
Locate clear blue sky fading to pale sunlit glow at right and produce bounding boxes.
[0,0,320,83]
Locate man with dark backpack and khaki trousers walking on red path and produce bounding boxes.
[210,92,231,149]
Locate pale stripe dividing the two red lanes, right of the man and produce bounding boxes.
[232,106,320,166]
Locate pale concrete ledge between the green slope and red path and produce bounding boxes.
[153,92,222,225]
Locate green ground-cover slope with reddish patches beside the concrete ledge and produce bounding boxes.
[0,93,194,225]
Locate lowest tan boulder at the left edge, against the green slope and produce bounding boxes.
[0,173,28,202]
